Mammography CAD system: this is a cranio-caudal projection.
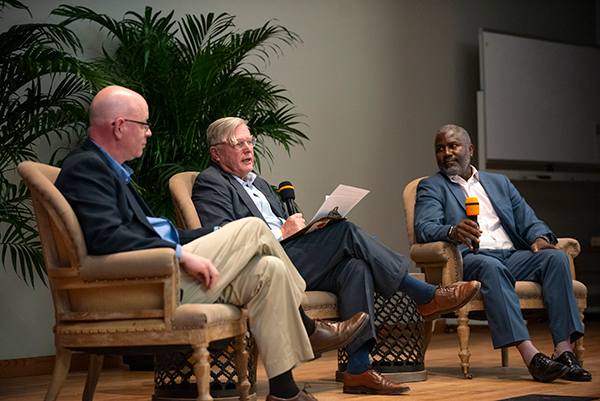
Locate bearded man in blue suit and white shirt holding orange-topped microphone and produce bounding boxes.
[415,125,591,381]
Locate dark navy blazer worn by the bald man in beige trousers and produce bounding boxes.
[55,139,213,255]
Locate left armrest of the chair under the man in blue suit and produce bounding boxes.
[410,241,462,285]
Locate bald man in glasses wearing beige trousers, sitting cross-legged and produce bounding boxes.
[56,86,367,401]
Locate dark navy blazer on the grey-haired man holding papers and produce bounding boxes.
[192,163,289,227]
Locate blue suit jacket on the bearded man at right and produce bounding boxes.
[415,171,557,252]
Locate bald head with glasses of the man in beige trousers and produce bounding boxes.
[90,85,152,163]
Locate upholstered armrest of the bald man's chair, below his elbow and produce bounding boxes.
[79,248,179,281]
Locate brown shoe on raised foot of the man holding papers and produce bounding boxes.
[417,281,481,320]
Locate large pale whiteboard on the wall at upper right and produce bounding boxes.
[479,29,600,173]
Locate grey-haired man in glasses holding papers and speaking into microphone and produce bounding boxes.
[192,117,479,395]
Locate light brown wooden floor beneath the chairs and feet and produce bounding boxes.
[0,320,600,401]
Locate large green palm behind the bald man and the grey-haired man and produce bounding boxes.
[52,5,307,219]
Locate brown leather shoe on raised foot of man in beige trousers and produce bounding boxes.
[308,312,369,356]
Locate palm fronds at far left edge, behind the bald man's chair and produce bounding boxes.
[0,0,105,287]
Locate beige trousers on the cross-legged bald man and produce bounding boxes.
[180,217,313,379]
